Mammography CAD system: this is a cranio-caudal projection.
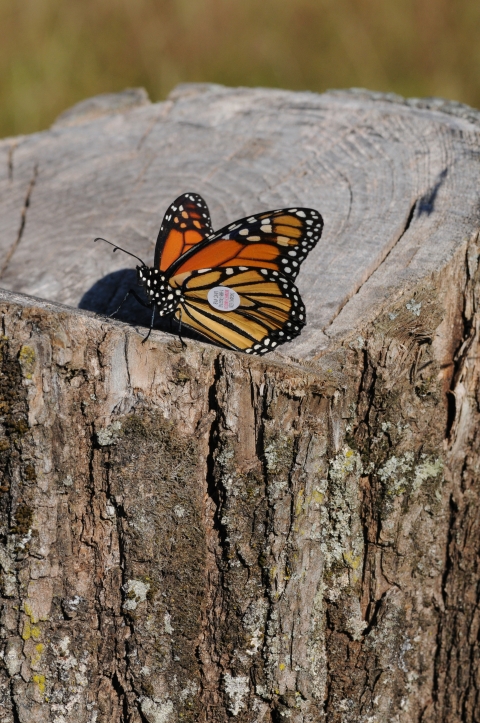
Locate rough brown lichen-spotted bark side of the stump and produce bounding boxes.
[0,233,478,723]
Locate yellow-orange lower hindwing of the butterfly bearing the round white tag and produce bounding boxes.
[169,266,305,354]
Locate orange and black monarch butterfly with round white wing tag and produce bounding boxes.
[95,193,323,354]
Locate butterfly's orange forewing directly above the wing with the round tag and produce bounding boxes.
[166,208,323,279]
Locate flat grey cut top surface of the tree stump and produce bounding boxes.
[0,85,479,360]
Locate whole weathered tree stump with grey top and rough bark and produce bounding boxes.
[0,85,480,723]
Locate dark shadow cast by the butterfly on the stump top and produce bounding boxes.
[78,269,205,341]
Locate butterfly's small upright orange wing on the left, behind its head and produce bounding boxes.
[154,193,213,271]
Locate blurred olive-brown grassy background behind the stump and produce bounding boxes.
[0,0,480,136]
